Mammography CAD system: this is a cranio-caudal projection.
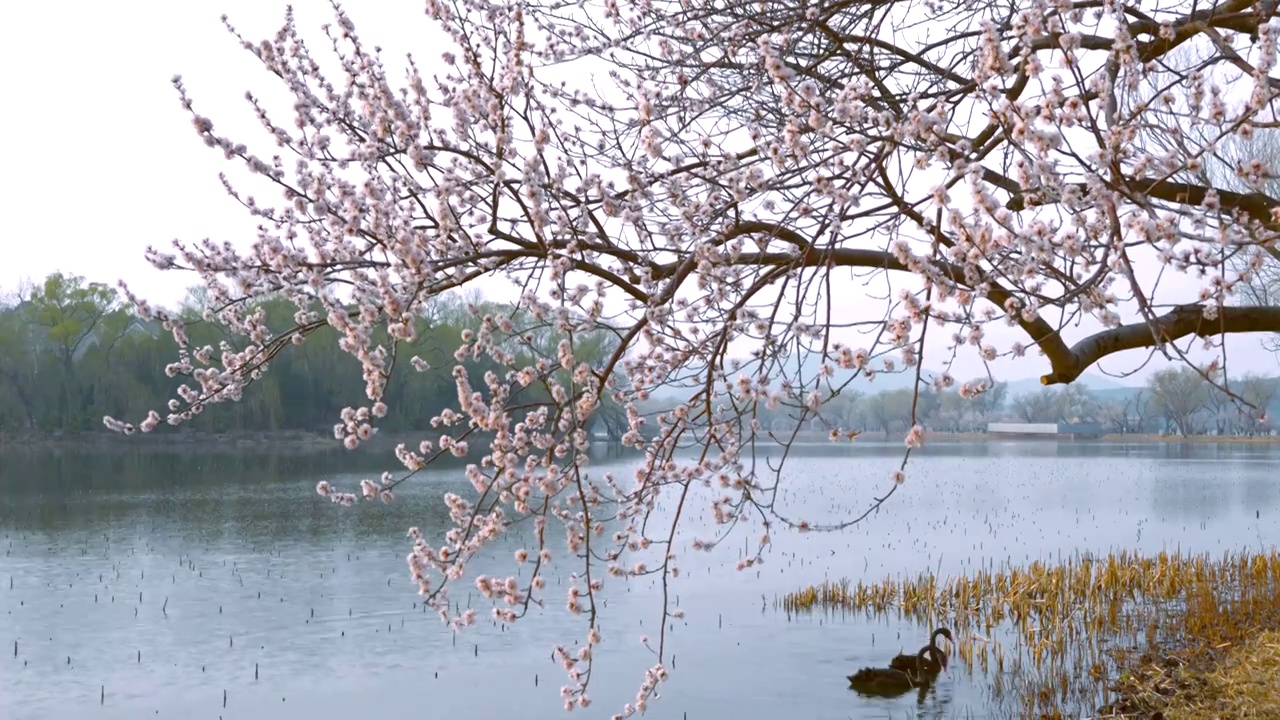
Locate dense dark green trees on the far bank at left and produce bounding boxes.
[0,273,626,437]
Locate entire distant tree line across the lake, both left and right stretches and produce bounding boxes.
[0,273,1280,439]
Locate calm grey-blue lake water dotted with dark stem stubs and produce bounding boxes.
[0,441,1280,720]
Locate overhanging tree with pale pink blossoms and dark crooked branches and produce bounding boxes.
[106,0,1280,714]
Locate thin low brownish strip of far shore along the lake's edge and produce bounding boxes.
[0,430,1280,452]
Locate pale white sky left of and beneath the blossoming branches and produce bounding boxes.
[0,0,1280,383]
